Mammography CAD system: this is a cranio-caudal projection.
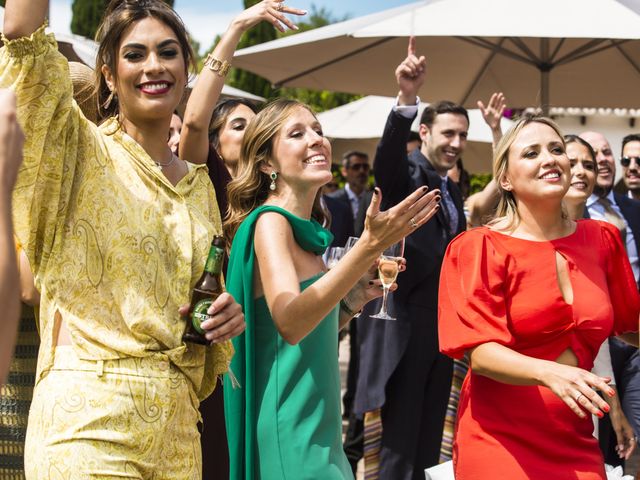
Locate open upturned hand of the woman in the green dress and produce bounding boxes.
[362,187,440,251]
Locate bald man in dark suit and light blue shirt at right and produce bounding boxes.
[580,132,640,465]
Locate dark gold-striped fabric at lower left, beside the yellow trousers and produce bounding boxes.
[0,304,40,480]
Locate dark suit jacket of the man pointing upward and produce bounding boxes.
[355,111,466,413]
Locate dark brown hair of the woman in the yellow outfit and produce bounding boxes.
[95,0,195,118]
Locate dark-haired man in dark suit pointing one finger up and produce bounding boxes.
[355,39,469,480]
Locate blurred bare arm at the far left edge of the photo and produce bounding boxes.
[0,90,24,383]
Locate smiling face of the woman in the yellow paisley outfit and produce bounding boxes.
[102,17,187,124]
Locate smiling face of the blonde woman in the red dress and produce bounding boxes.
[500,122,570,202]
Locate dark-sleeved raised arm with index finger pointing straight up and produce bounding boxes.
[373,37,426,204]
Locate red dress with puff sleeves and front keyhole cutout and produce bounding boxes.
[438,220,640,480]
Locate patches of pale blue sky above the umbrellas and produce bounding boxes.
[50,0,413,49]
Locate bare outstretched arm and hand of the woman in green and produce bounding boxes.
[255,187,439,344]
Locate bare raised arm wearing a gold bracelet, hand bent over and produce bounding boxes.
[180,0,307,163]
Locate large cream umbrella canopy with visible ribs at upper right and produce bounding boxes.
[234,0,640,108]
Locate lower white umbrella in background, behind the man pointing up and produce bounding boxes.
[318,95,513,173]
